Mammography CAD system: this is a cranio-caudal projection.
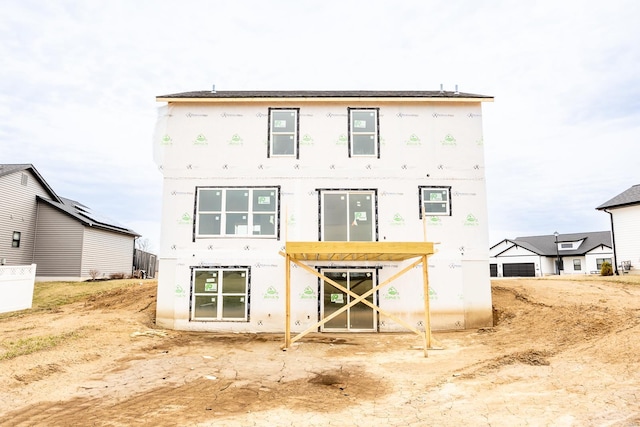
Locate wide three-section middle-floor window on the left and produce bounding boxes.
[195,187,280,238]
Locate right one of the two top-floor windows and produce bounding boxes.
[348,108,380,157]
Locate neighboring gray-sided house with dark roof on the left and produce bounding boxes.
[0,164,139,280]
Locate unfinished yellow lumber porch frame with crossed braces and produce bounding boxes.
[280,242,434,357]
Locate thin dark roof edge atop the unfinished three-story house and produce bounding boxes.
[156,90,493,100]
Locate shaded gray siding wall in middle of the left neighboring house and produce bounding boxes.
[35,203,84,277]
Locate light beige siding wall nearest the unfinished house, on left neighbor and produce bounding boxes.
[81,227,134,277]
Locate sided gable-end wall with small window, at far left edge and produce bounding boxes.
[0,170,50,265]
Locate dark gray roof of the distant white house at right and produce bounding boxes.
[496,231,612,256]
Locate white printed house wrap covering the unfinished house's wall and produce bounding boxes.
[153,98,492,332]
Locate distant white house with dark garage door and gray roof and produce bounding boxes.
[489,231,613,277]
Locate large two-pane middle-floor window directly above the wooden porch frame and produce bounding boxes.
[320,190,377,242]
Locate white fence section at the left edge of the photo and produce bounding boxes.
[0,264,36,313]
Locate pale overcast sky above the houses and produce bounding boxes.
[0,0,640,250]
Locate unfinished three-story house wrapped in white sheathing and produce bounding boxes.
[154,91,493,332]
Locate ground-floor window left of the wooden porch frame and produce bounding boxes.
[191,267,249,321]
